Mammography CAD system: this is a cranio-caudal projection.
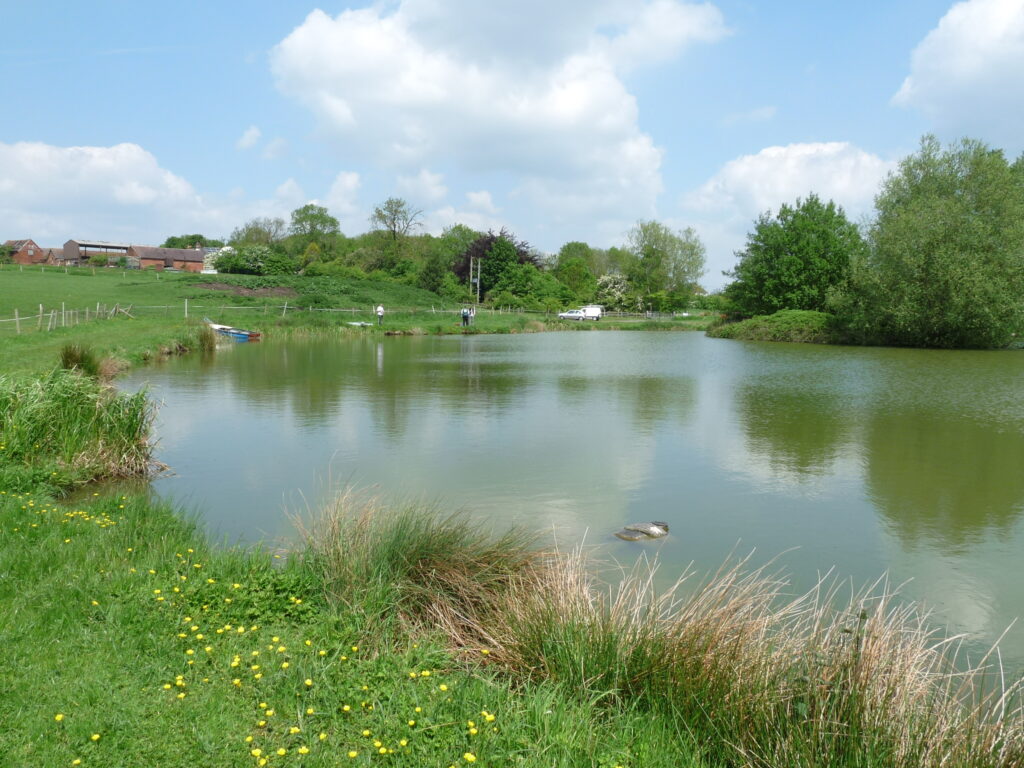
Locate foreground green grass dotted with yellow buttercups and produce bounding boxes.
[0,492,702,768]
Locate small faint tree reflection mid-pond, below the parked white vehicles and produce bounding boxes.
[557,375,696,434]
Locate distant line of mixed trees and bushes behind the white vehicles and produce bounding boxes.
[163,198,706,319]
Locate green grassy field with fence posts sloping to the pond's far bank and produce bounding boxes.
[0,265,710,373]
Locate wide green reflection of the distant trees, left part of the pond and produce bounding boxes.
[195,339,526,434]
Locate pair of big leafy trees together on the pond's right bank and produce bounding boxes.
[723,135,1024,348]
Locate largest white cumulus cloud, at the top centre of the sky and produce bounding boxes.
[270,0,727,243]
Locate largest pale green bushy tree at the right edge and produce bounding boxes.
[834,136,1024,348]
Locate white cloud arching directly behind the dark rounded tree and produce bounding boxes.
[683,141,895,288]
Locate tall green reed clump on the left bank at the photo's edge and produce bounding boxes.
[0,369,154,483]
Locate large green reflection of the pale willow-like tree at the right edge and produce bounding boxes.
[865,413,1024,549]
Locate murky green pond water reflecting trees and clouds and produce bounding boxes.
[125,332,1024,673]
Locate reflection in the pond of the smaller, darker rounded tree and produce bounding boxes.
[736,384,849,475]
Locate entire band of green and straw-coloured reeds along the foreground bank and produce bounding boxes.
[306,495,1024,768]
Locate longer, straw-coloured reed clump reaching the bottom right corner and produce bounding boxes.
[483,554,1024,768]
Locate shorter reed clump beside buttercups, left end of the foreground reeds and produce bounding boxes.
[300,492,540,629]
